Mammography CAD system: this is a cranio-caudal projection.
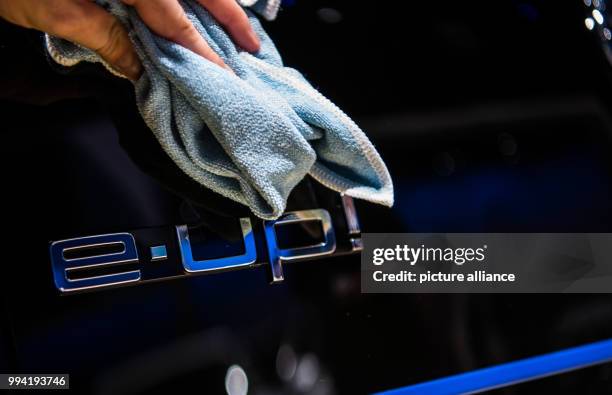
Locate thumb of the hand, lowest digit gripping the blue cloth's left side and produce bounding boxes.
[49,1,142,80]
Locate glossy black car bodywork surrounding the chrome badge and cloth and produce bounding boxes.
[0,0,612,395]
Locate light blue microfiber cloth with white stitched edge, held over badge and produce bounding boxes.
[46,0,393,219]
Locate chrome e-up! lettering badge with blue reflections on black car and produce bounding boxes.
[50,196,361,294]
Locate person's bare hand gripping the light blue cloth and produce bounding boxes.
[0,0,259,80]
